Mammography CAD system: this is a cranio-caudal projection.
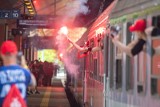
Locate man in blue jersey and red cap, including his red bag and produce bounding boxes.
[0,41,36,107]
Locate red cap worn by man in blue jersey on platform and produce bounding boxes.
[0,40,18,55]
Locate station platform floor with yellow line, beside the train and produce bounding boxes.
[27,78,70,107]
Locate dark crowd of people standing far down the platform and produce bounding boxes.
[27,60,59,95]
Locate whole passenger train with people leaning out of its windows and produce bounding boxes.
[66,0,160,107]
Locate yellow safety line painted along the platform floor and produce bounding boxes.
[40,87,51,107]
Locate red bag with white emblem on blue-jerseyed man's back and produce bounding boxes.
[2,84,27,107]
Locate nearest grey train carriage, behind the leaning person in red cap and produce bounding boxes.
[107,0,160,107]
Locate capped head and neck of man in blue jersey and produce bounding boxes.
[0,40,18,64]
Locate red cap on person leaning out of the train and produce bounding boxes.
[129,19,146,32]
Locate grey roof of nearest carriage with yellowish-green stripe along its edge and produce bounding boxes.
[110,0,160,23]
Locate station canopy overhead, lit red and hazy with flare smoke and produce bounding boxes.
[0,0,113,49]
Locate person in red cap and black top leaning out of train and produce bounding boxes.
[111,19,160,57]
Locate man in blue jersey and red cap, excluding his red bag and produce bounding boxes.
[0,40,36,107]
